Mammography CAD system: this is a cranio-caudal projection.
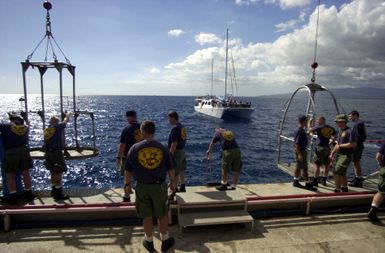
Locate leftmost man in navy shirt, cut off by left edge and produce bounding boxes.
[0,114,35,205]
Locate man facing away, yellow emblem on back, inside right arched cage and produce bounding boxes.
[308,116,336,187]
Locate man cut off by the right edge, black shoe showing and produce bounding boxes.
[368,142,385,222]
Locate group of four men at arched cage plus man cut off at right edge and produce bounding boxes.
[293,111,385,221]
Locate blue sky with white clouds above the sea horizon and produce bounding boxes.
[0,0,385,96]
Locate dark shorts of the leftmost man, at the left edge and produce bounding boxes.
[4,146,33,173]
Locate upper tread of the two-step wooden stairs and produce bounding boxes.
[176,190,246,205]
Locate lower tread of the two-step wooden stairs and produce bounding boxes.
[178,210,254,227]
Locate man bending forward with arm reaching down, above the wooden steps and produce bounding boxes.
[206,127,242,191]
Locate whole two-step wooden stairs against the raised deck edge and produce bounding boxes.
[176,190,254,230]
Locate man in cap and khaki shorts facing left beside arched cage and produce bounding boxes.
[330,114,358,192]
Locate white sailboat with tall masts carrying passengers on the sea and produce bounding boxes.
[194,29,254,119]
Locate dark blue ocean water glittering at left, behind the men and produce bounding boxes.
[0,95,385,189]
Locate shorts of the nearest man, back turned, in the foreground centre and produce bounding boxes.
[135,183,168,219]
